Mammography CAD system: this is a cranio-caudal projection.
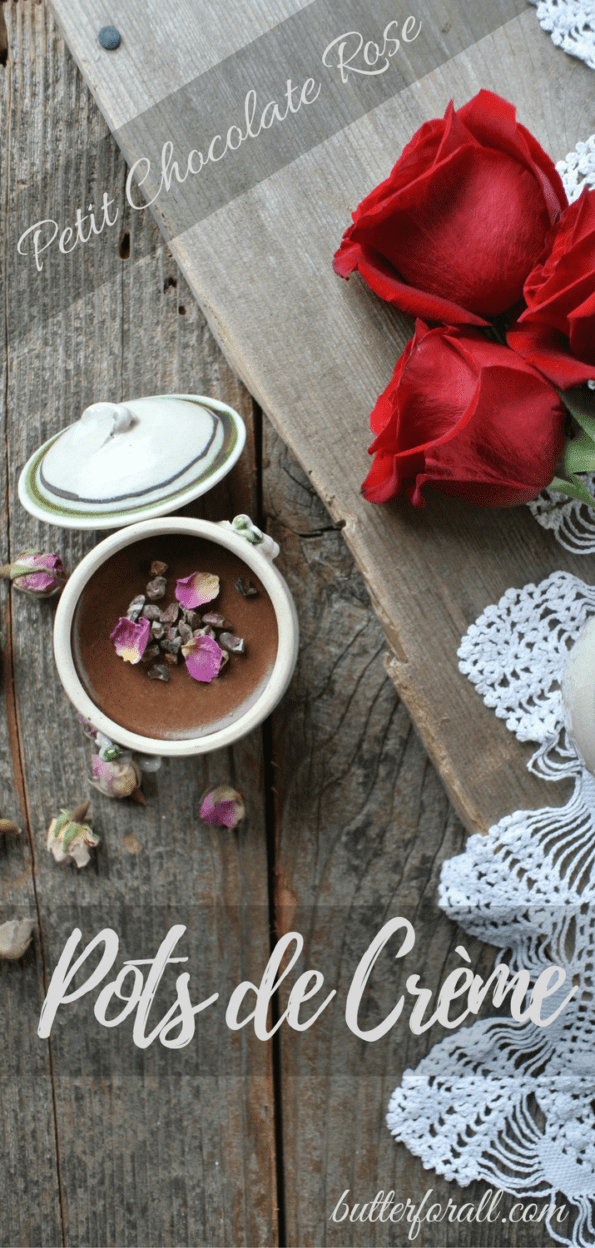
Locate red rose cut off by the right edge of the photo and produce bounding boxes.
[508,191,595,389]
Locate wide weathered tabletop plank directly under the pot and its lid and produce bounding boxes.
[0,2,277,1246]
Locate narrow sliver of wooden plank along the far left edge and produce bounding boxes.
[0,9,62,1246]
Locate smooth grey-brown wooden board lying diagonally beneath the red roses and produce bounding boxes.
[46,0,595,829]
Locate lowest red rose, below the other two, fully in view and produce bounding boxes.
[362,321,564,507]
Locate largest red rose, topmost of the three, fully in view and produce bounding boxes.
[333,91,568,324]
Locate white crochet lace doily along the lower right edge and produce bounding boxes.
[387,572,595,1248]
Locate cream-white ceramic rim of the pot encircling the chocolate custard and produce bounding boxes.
[54,517,298,756]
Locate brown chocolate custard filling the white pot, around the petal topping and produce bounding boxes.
[72,533,278,740]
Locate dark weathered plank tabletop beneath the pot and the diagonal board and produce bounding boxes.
[0,0,573,1248]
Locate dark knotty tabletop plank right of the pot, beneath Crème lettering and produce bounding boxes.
[264,428,551,1248]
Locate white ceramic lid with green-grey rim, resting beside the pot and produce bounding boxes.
[19,394,246,529]
